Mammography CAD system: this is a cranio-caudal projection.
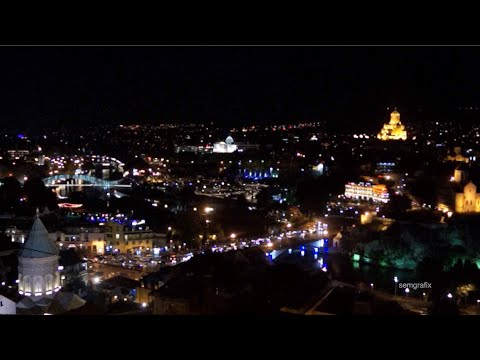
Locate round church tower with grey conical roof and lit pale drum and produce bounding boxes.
[18,210,60,301]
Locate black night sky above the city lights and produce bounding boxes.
[0,47,480,129]
